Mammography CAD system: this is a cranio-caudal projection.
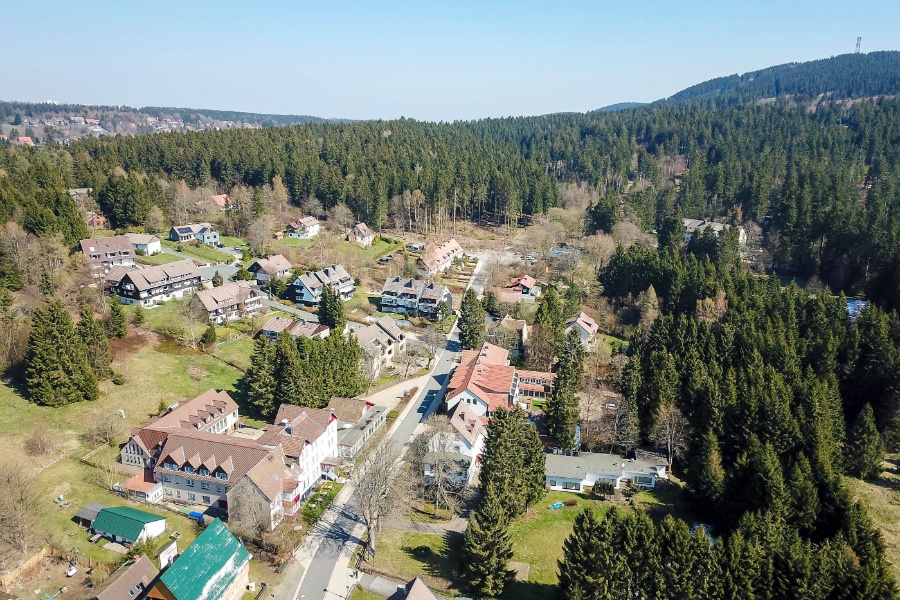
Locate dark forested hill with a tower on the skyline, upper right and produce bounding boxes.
[660,51,900,104]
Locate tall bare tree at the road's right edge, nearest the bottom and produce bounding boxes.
[353,437,401,553]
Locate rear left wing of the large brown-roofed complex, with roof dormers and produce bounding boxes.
[120,389,238,469]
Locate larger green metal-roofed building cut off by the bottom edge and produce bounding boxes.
[160,519,250,600]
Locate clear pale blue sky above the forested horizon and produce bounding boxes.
[7,0,900,120]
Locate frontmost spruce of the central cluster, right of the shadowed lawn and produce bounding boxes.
[461,488,514,597]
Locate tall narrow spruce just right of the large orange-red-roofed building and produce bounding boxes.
[546,329,584,451]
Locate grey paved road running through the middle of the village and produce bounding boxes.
[279,261,485,600]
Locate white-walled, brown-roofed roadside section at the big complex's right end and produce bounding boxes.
[257,404,340,506]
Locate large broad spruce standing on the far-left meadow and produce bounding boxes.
[25,301,100,406]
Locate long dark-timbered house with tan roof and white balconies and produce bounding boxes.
[106,259,202,308]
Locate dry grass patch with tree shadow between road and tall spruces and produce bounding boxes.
[374,529,462,596]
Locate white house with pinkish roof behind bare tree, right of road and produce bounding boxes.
[424,403,487,485]
